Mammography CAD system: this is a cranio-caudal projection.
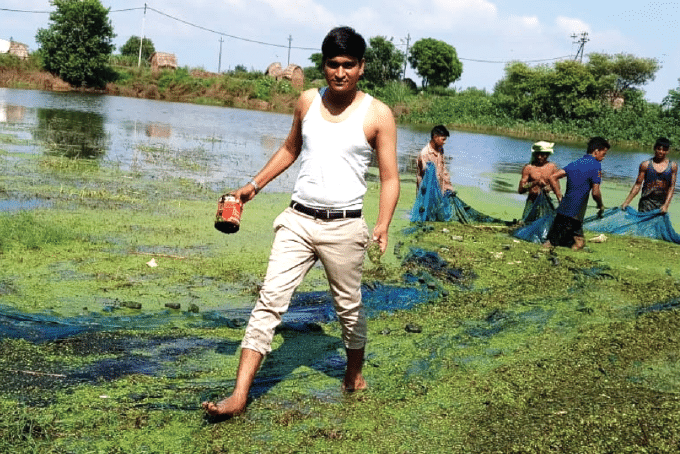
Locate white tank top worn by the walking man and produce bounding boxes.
[292,89,373,210]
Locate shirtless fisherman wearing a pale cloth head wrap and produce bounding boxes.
[517,141,559,222]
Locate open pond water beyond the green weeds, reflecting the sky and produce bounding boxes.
[0,89,652,198]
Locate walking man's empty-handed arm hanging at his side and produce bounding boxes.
[372,100,399,253]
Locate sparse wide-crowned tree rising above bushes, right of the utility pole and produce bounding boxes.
[586,53,661,101]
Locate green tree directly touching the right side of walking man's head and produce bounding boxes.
[364,36,404,87]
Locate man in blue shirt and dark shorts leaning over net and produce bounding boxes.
[543,137,611,251]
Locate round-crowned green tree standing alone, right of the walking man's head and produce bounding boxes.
[408,38,463,87]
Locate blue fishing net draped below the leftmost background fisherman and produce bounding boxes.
[411,162,513,224]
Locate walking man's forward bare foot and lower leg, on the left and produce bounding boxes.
[202,348,264,416]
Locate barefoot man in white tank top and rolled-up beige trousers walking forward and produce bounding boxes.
[203,27,399,416]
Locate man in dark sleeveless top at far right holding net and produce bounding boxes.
[621,137,678,213]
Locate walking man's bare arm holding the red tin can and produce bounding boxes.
[233,90,316,203]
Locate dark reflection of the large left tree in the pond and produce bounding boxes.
[33,109,107,159]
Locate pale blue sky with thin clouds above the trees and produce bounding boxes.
[0,0,680,102]
